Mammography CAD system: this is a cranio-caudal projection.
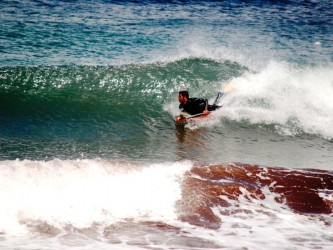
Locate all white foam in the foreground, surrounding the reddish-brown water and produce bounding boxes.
[0,160,333,249]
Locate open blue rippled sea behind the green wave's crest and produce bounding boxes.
[0,1,332,66]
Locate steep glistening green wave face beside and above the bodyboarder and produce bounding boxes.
[0,59,243,120]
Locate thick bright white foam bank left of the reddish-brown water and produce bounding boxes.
[0,160,192,235]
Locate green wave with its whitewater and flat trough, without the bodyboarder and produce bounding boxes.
[0,58,332,168]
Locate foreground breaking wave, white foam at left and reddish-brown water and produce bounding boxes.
[0,160,333,249]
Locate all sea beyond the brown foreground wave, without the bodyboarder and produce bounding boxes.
[0,1,333,168]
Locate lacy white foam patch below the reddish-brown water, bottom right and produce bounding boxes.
[183,187,333,250]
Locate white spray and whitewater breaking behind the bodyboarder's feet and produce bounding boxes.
[218,62,333,138]
